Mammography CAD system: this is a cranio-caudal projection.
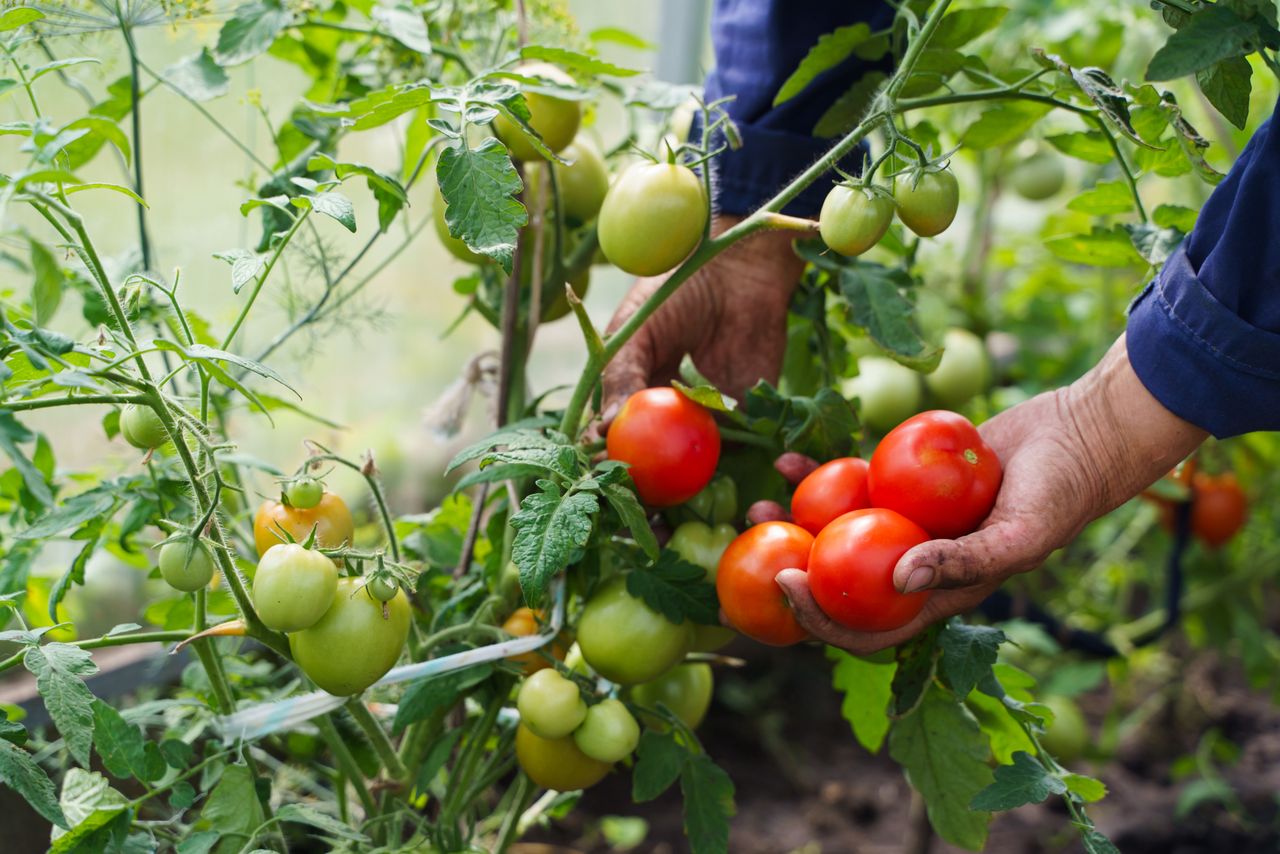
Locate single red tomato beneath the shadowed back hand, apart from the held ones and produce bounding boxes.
[605,388,719,507]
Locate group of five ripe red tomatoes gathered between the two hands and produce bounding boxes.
[607,388,1001,645]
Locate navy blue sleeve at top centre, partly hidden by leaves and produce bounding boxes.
[705,0,893,216]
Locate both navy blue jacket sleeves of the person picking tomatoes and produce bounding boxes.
[707,0,1280,437]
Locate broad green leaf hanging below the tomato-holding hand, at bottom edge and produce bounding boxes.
[888,685,993,851]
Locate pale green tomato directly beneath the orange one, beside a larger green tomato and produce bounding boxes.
[253,543,338,631]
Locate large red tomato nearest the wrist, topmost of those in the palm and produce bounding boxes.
[867,410,998,539]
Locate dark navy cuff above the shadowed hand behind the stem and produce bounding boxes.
[695,122,863,216]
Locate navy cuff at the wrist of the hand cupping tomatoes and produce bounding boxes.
[1126,248,1280,438]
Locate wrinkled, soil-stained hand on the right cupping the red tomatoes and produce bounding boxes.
[777,337,1206,654]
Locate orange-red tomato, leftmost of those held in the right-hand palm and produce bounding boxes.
[716,522,813,647]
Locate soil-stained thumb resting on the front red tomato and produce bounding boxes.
[893,522,1053,593]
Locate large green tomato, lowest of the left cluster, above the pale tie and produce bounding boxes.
[289,577,411,697]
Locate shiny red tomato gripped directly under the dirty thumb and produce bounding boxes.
[809,507,929,631]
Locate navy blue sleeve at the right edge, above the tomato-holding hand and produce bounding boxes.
[1126,104,1280,438]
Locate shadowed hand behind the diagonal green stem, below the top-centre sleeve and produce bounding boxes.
[600,215,804,425]
